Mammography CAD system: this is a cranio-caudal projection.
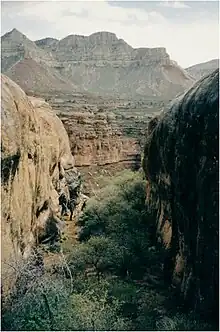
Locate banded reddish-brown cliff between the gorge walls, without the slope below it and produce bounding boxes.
[59,112,140,168]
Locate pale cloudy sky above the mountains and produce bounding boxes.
[1,0,219,68]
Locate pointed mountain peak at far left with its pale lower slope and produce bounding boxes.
[1,29,76,93]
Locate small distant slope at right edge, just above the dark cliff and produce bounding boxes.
[186,59,219,80]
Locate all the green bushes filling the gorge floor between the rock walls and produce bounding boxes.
[2,171,213,331]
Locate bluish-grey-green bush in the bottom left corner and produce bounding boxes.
[2,276,69,331]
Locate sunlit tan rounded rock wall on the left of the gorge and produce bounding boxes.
[1,75,80,286]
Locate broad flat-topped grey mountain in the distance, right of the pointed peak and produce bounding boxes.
[36,31,193,97]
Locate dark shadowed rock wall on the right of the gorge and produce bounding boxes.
[143,70,219,315]
